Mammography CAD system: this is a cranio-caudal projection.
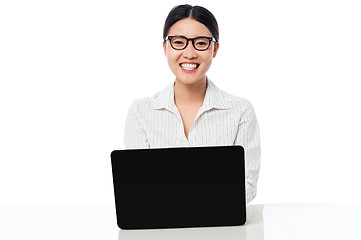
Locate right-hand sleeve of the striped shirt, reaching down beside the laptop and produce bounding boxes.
[235,102,261,204]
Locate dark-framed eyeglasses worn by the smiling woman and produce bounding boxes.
[164,36,217,51]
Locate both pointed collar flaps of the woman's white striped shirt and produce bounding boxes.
[149,77,229,111]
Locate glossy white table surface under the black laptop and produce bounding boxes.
[0,204,361,240]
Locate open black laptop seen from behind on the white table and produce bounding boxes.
[111,145,246,229]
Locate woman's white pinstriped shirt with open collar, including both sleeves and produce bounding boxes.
[124,78,261,203]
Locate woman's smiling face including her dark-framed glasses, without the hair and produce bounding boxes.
[163,18,219,86]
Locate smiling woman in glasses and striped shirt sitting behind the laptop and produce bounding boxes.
[124,5,260,203]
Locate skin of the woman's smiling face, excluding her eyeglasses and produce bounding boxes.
[163,18,219,84]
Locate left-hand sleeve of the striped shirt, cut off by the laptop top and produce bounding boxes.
[124,102,150,149]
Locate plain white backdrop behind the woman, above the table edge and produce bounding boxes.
[0,0,361,205]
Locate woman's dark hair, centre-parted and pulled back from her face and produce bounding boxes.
[163,4,219,42]
